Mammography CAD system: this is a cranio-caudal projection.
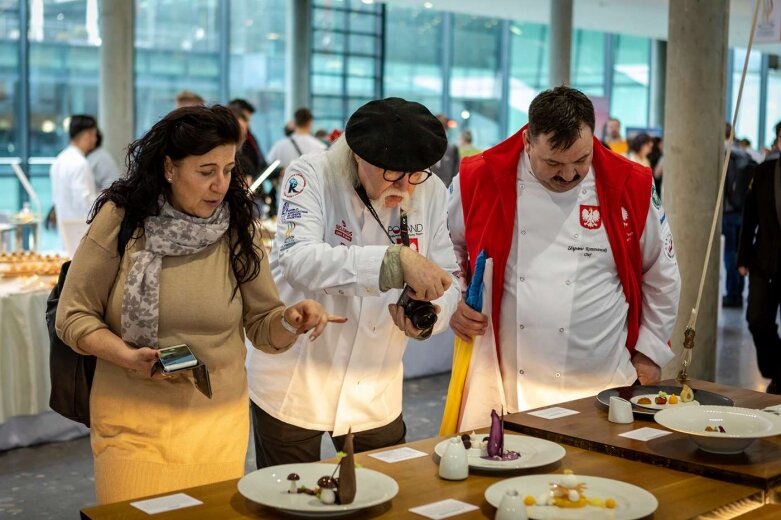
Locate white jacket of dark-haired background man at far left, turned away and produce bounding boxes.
[50,145,97,221]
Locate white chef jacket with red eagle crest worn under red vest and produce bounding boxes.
[448,153,680,412]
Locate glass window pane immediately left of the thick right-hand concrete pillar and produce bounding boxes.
[610,35,651,131]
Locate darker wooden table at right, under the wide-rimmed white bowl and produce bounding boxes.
[504,381,781,491]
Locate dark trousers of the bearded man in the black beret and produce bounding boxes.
[250,403,407,469]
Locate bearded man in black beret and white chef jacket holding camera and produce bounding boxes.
[247,98,460,467]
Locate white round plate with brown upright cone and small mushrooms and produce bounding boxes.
[239,463,399,517]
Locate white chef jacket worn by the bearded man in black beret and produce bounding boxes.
[247,152,460,435]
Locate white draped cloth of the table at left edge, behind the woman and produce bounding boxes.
[0,278,88,451]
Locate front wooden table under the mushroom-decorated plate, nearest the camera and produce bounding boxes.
[81,432,760,520]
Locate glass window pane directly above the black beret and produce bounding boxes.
[383,5,444,114]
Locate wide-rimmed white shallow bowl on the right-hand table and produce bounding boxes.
[654,405,781,455]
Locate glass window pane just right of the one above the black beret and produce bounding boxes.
[445,15,505,148]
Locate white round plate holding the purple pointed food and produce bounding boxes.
[434,433,567,471]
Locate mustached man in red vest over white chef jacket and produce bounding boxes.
[449,86,680,412]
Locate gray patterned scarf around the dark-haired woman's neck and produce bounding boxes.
[122,202,230,347]
